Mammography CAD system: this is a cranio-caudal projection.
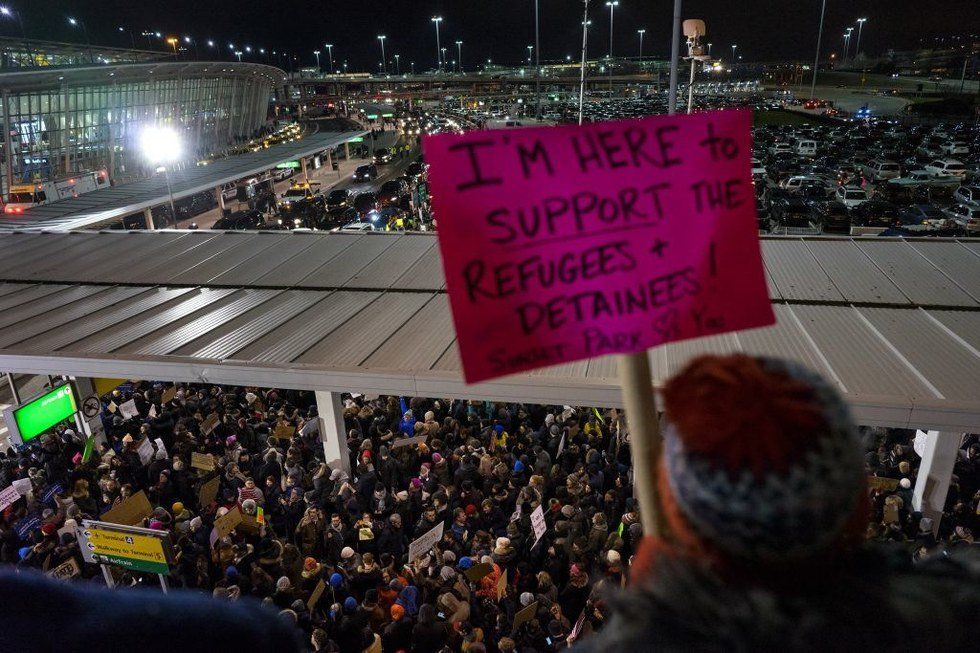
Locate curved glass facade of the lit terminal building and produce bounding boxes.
[0,62,284,194]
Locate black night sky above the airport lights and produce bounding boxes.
[9,0,980,71]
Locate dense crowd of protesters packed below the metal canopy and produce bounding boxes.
[0,364,980,653]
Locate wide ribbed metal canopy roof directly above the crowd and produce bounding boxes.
[0,231,980,431]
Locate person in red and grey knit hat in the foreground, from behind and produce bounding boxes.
[572,354,980,653]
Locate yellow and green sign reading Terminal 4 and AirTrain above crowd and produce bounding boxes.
[77,520,174,574]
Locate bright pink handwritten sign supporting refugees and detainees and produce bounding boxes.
[423,111,775,383]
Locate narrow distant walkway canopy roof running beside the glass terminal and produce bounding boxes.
[0,131,367,232]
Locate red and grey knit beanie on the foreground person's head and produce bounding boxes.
[660,354,867,562]
